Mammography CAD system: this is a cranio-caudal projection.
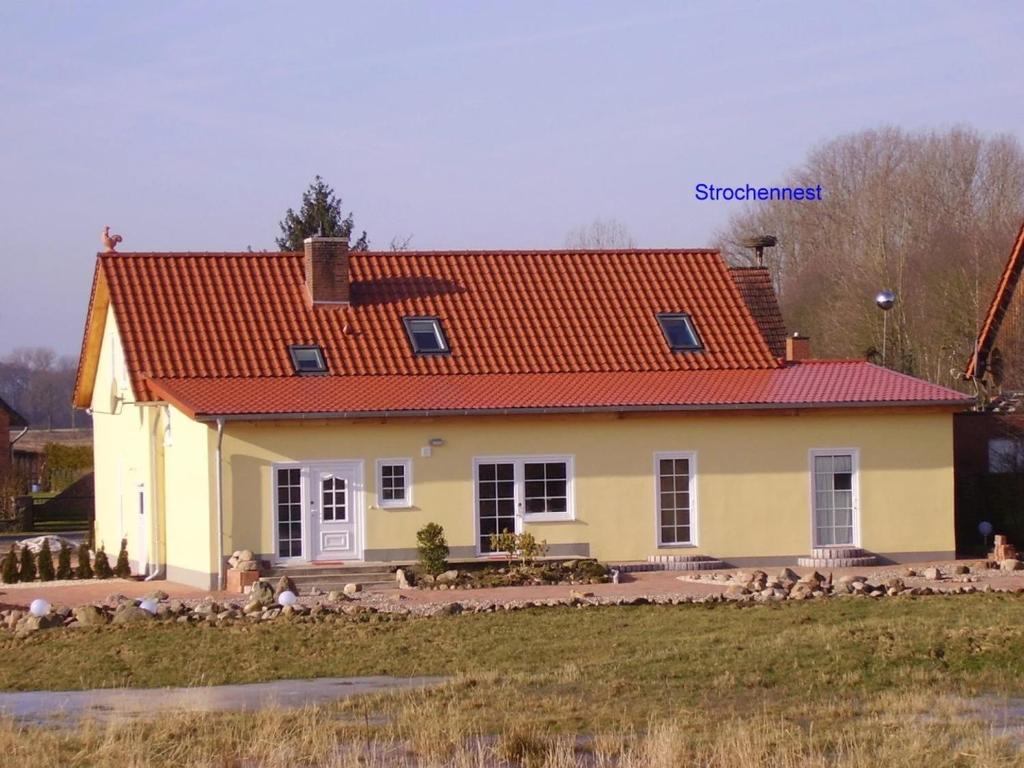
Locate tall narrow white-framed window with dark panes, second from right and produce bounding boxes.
[654,451,697,547]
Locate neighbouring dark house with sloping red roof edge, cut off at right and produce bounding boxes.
[953,226,1024,554]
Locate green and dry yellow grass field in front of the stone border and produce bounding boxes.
[0,595,1024,766]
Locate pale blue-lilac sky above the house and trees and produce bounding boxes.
[0,0,1024,355]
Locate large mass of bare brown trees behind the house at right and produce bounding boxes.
[719,128,1024,391]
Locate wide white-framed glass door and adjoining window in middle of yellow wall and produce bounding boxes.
[473,455,575,552]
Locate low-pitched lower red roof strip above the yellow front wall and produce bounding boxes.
[151,360,972,419]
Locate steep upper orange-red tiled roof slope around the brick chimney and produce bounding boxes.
[75,250,778,400]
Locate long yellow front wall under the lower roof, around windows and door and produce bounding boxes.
[214,411,954,562]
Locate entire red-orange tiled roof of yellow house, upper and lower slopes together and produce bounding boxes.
[75,250,970,419]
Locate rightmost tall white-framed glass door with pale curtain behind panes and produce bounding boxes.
[811,449,860,547]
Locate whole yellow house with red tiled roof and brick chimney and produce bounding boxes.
[75,238,970,587]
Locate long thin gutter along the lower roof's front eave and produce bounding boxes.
[186,397,974,428]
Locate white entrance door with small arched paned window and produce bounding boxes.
[309,463,362,561]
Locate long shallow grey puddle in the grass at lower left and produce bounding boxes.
[0,677,444,724]
